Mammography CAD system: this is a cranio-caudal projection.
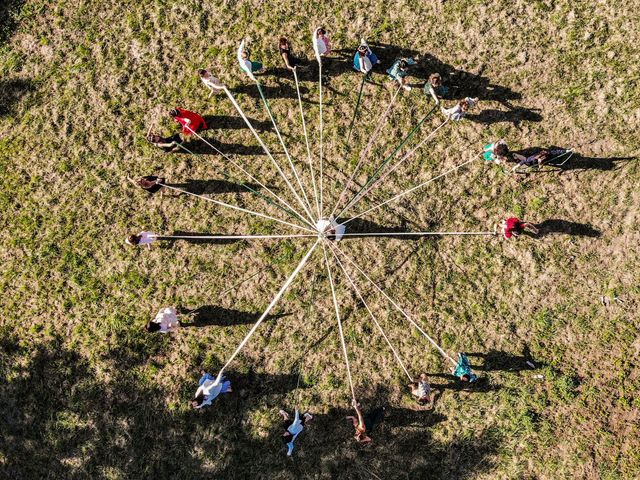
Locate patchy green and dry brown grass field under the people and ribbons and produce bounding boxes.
[0,0,640,479]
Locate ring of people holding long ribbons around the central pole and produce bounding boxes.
[126,27,571,456]
